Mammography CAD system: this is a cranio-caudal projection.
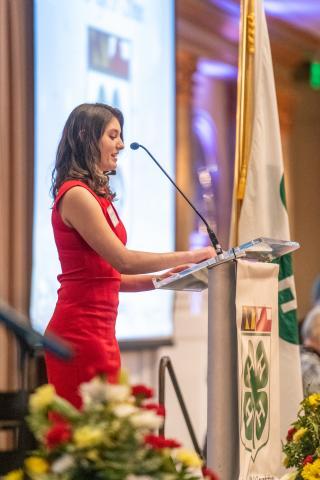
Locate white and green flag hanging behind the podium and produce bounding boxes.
[238,0,302,478]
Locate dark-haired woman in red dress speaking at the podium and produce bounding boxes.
[46,103,215,408]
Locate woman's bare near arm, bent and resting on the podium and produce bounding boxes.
[59,186,215,274]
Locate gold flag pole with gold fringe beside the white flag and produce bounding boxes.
[230,0,255,246]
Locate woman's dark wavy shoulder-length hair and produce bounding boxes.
[51,103,123,198]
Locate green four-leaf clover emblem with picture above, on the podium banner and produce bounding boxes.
[240,306,272,462]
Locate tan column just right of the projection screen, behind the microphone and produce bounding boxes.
[176,50,197,250]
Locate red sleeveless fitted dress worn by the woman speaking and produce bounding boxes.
[43,180,127,408]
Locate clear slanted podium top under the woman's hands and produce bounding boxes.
[153,237,300,292]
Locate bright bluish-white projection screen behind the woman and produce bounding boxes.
[31,0,175,340]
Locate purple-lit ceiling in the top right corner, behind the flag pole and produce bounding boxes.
[210,0,320,39]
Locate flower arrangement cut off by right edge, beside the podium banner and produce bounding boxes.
[282,393,320,480]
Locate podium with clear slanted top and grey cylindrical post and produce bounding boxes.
[154,237,299,480]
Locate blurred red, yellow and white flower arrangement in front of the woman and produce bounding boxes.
[4,377,217,480]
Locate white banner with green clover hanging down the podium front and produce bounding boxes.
[236,260,281,480]
